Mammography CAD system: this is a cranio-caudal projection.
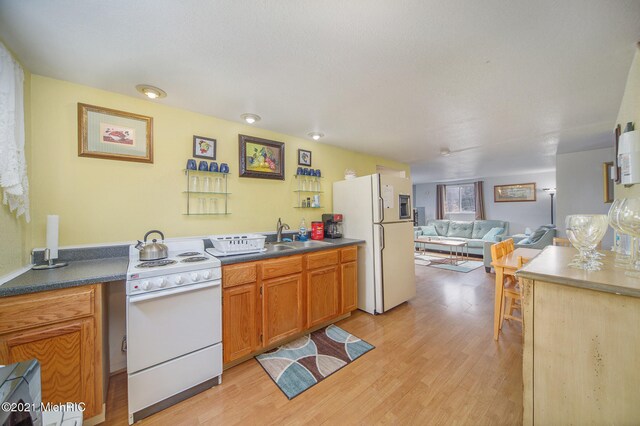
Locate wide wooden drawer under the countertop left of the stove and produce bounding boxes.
[0,286,96,334]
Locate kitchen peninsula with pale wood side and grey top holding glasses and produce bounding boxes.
[516,246,640,425]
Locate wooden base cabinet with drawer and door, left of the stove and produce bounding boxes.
[0,284,103,419]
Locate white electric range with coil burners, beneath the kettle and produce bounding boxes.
[127,239,222,424]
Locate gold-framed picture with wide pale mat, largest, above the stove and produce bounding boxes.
[78,103,153,163]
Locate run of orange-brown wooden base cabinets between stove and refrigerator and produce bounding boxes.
[222,246,358,365]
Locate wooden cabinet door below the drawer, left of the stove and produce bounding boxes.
[0,318,97,418]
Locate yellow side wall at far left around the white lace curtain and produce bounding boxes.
[0,48,31,277]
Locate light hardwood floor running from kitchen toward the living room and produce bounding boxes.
[106,266,522,425]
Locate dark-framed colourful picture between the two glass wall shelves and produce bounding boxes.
[238,135,284,180]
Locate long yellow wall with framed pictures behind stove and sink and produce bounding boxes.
[30,75,409,247]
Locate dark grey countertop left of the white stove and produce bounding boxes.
[0,257,129,297]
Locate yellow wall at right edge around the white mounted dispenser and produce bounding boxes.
[614,45,640,198]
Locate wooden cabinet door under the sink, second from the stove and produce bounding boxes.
[262,274,303,346]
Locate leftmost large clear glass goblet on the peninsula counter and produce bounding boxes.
[566,214,608,271]
